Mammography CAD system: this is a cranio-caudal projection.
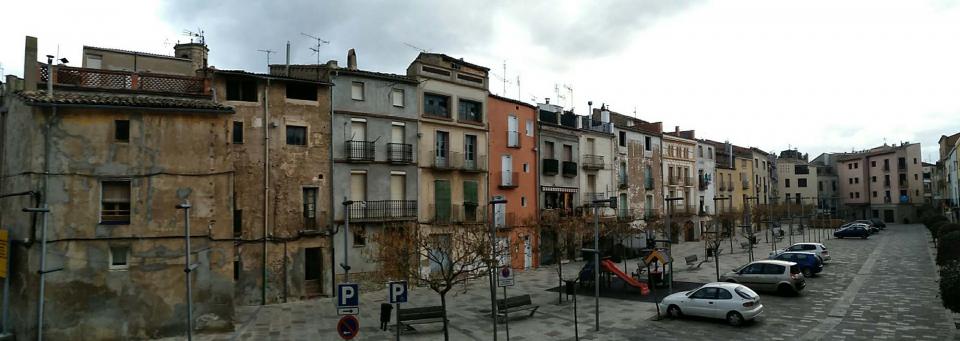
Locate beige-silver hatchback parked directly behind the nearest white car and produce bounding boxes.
[720,260,806,294]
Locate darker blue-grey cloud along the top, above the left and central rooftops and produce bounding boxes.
[163,0,693,73]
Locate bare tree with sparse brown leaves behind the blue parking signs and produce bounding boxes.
[375,219,504,340]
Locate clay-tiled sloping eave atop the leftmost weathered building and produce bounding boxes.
[17,90,233,113]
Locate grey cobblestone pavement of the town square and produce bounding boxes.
[176,224,957,340]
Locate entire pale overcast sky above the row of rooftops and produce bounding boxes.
[0,0,960,161]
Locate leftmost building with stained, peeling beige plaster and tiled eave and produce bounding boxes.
[0,37,236,340]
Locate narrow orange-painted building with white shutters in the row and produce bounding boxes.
[487,95,540,269]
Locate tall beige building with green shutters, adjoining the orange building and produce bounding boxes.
[407,53,489,267]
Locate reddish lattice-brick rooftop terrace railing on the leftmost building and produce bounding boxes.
[37,63,208,95]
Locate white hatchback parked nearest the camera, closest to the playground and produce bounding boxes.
[660,282,763,326]
